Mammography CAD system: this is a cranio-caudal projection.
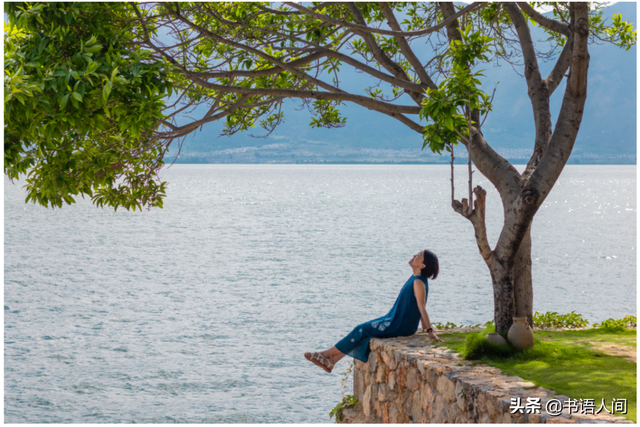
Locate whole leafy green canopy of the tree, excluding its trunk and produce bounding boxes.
[4,2,636,214]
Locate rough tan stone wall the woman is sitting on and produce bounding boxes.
[343,335,631,423]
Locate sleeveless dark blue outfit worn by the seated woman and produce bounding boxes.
[336,276,429,362]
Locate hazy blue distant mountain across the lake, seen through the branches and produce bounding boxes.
[172,2,637,164]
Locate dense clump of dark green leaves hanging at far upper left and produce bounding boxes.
[4,3,171,209]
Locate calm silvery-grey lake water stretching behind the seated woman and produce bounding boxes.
[4,165,636,423]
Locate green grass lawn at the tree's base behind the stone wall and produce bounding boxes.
[439,329,637,422]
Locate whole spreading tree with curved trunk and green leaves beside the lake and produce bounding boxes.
[5,2,636,333]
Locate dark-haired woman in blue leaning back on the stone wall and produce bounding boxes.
[304,250,442,373]
